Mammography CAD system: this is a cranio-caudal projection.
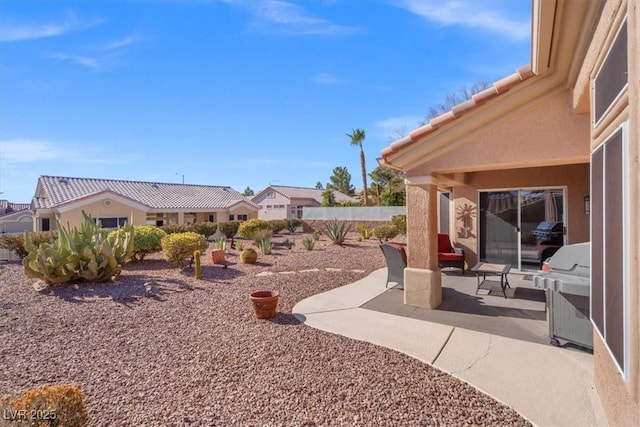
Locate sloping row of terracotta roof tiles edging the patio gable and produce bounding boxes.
[381,64,534,158]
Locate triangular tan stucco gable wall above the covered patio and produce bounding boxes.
[408,90,589,176]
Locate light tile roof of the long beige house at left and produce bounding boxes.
[33,176,258,209]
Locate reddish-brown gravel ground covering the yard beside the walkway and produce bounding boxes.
[0,235,530,426]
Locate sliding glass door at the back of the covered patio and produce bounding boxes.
[479,188,566,270]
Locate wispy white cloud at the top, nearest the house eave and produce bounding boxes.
[394,0,531,40]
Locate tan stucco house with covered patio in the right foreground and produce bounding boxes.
[380,0,640,425]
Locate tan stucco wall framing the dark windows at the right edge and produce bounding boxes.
[592,0,640,426]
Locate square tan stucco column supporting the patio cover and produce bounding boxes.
[404,176,442,308]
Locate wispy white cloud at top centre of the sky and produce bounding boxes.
[228,0,360,35]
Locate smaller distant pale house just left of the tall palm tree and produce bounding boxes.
[251,185,358,220]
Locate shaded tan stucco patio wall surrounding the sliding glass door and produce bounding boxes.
[450,164,590,267]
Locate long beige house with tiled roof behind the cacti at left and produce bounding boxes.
[31,176,258,231]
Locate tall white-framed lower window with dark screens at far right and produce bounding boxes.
[590,123,630,381]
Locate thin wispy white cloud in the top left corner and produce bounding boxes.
[0,12,103,42]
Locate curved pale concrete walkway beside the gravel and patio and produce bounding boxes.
[293,268,608,427]
